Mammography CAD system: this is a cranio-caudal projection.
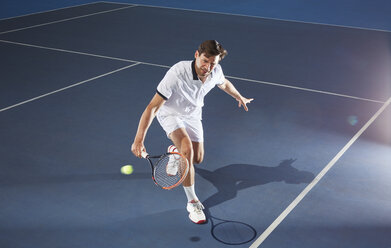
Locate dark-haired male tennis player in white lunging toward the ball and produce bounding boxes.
[132,40,253,224]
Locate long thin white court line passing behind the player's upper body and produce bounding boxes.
[0,40,384,103]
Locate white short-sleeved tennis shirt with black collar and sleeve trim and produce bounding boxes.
[157,60,225,120]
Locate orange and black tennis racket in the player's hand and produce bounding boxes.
[141,152,189,189]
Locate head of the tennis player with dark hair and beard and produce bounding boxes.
[194,40,227,77]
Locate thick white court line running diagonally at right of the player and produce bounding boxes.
[250,98,391,248]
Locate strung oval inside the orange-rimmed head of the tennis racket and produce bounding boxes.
[154,154,188,188]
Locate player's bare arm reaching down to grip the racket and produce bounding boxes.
[132,93,165,158]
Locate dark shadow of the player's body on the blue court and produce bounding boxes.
[196,159,315,208]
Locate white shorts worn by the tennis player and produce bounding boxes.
[156,115,204,142]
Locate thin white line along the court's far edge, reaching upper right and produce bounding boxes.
[102,1,391,33]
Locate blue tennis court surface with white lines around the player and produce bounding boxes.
[0,2,391,248]
